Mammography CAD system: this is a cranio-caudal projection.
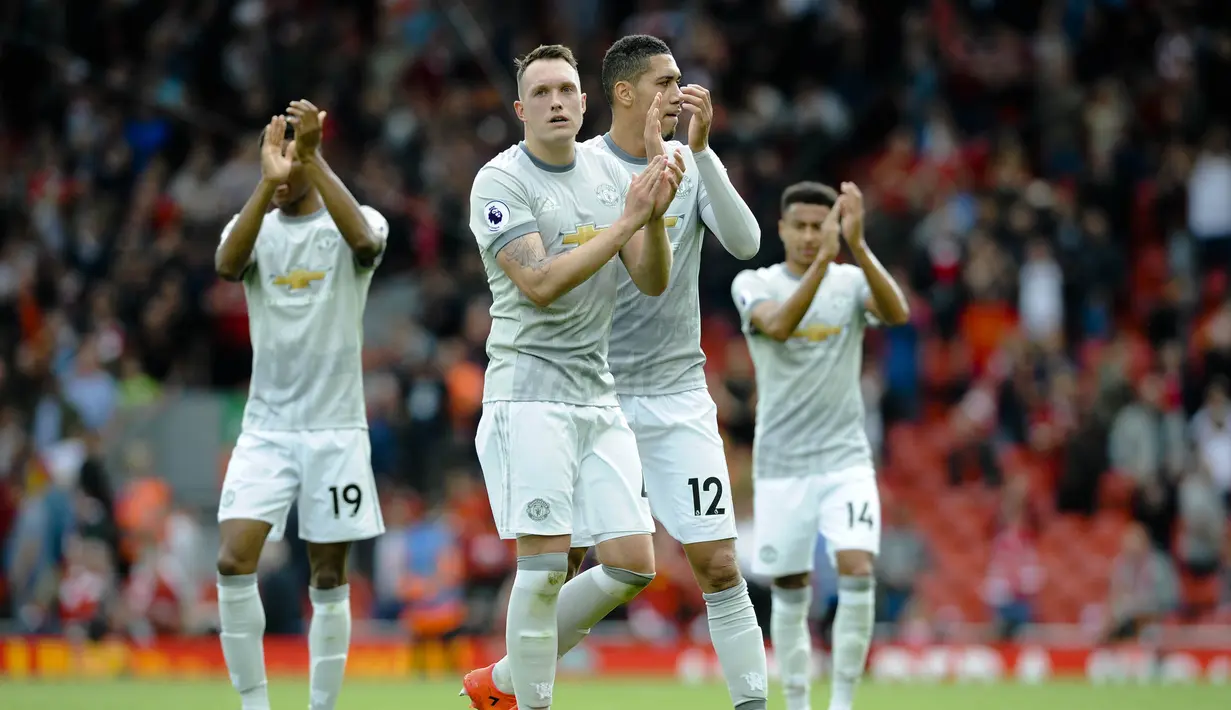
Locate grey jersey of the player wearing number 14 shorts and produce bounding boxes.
[731,263,872,479]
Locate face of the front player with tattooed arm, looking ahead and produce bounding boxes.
[513,59,586,143]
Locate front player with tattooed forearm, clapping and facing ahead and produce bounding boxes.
[463,44,683,710]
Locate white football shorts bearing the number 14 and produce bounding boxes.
[752,466,880,577]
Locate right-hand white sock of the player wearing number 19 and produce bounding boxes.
[308,584,351,710]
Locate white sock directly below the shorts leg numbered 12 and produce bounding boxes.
[703,580,768,710]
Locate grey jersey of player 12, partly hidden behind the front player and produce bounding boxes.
[586,135,709,395]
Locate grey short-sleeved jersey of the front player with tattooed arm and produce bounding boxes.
[470,143,630,406]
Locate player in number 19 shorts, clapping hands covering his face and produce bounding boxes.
[214,101,389,710]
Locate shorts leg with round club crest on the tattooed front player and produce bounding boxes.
[475,402,580,540]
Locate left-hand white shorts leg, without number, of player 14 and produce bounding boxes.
[752,476,820,577]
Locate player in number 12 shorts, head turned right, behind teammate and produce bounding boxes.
[472,34,767,710]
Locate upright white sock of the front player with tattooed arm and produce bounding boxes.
[505,552,569,710]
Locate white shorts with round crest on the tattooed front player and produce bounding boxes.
[475,401,654,541]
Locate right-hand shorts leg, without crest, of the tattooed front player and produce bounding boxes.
[574,407,654,546]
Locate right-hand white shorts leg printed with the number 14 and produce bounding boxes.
[820,466,880,561]
